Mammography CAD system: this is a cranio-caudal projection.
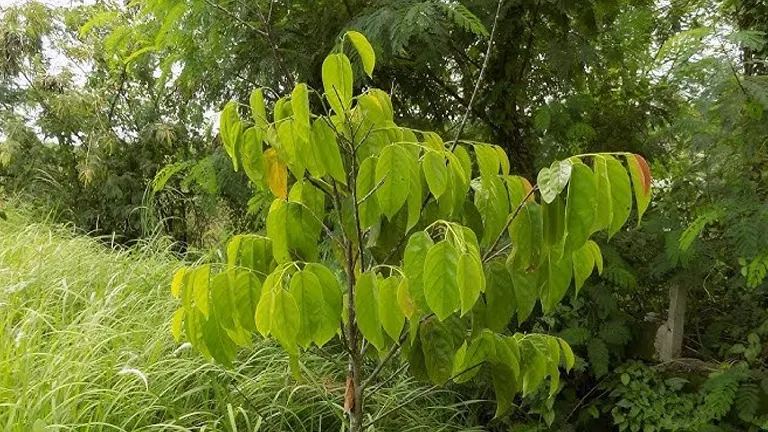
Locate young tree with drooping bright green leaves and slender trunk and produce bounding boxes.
[166,32,651,431]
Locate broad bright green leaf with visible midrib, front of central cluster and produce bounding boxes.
[424,240,461,321]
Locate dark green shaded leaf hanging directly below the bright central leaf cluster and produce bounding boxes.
[419,318,455,385]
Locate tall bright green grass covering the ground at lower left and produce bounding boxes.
[0,211,480,432]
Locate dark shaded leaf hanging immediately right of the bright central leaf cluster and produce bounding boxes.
[485,261,516,332]
